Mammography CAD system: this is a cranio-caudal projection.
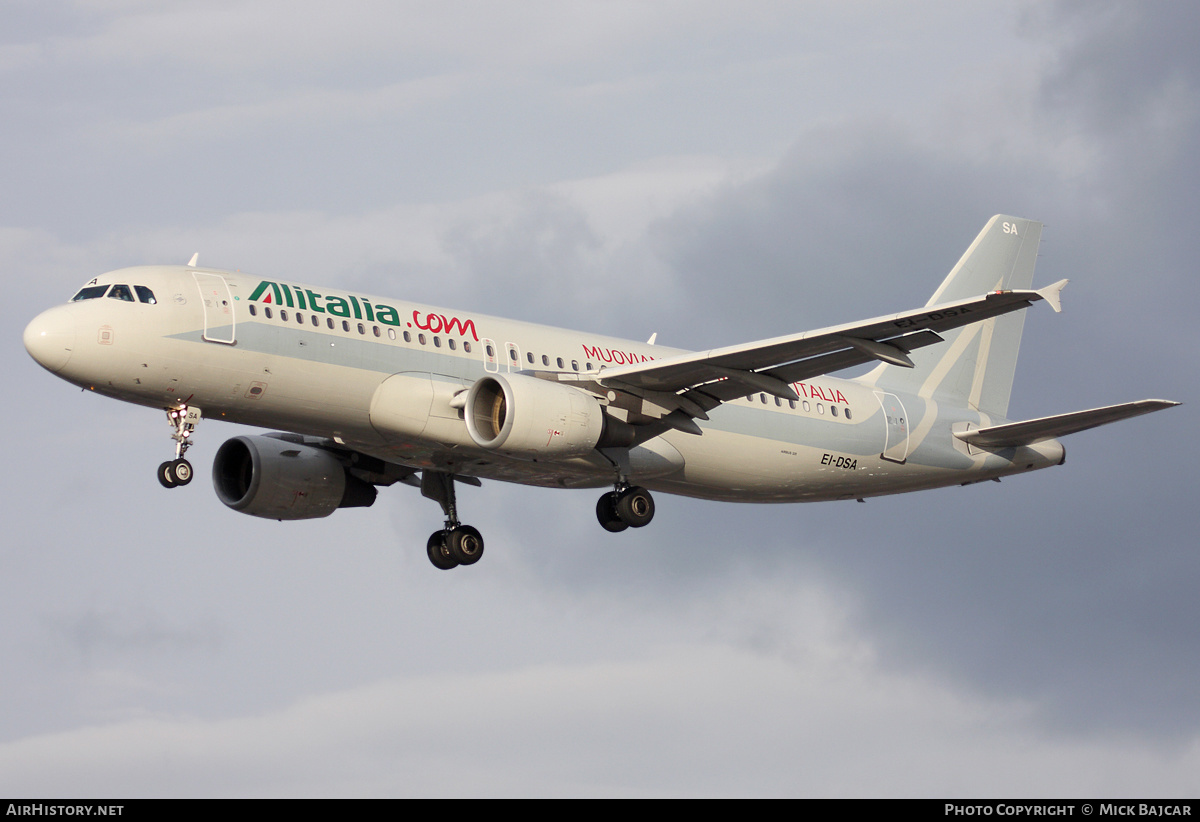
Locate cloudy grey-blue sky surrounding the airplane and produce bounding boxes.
[0,0,1200,797]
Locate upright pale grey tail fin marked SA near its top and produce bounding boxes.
[864,215,1042,416]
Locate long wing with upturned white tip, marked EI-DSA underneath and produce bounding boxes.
[558,280,1067,433]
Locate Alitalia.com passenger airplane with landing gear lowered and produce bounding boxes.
[24,215,1180,570]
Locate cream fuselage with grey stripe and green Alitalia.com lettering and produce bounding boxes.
[25,266,1063,502]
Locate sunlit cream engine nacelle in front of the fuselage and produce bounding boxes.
[463,374,605,460]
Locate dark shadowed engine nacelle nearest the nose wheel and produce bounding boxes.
[212,437,376,520]
